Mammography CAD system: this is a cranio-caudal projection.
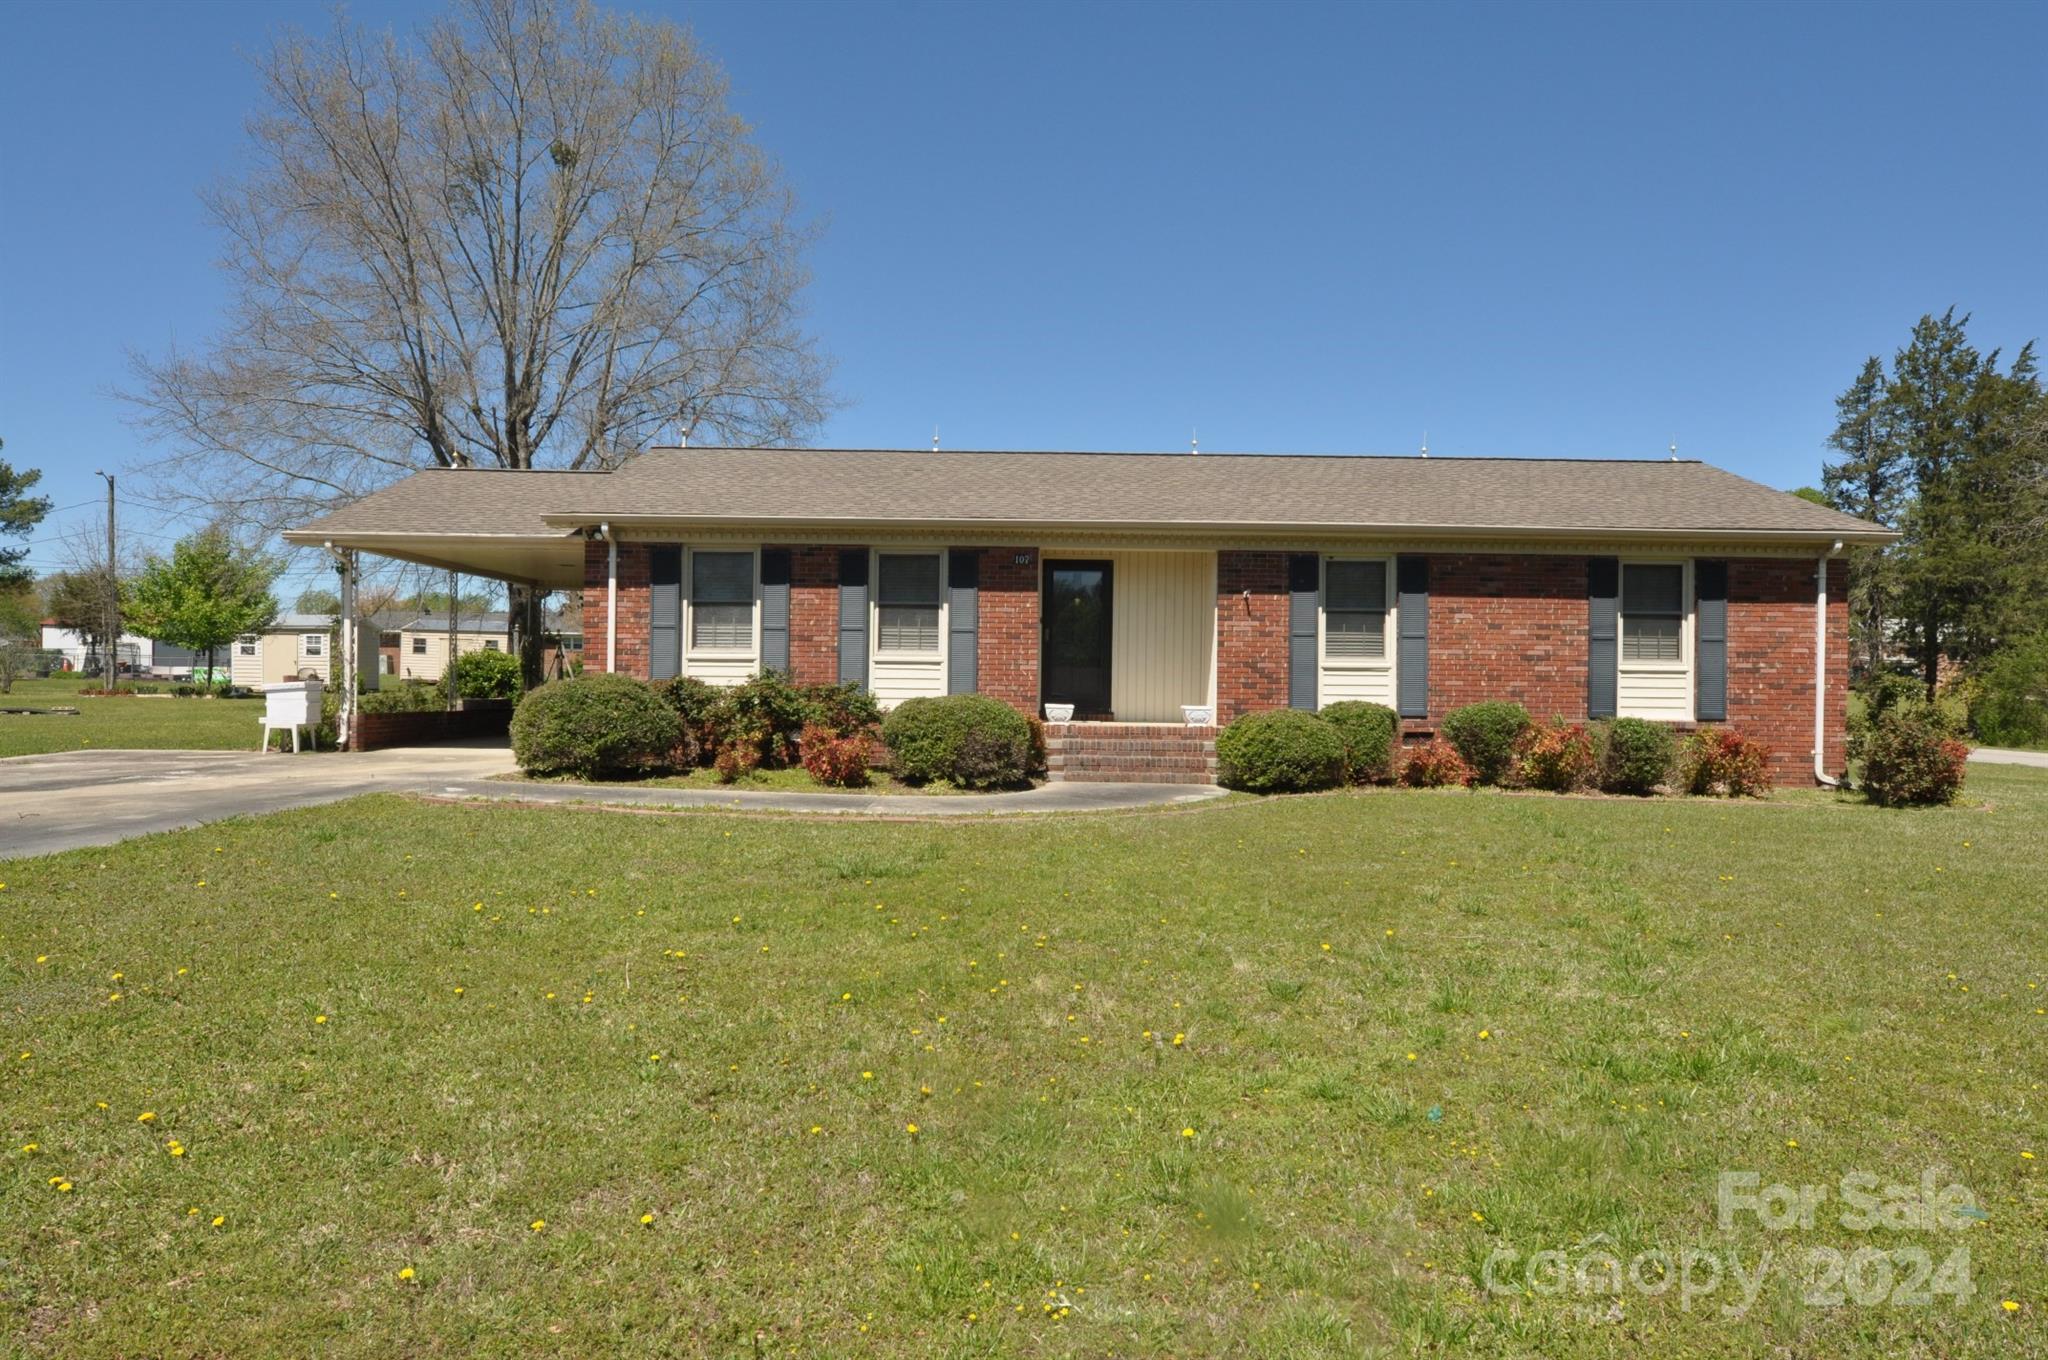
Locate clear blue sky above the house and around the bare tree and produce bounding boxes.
[0,0,2048,593]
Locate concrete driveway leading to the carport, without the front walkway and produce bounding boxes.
[0,737,512,858]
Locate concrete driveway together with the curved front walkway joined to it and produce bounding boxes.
[0,737,1223,860]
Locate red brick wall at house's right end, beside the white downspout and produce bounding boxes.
[1726,557,1849,787]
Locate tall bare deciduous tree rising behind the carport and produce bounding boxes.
[131,0,827,666]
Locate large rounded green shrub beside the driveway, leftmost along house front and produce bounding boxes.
[512,674,682,778]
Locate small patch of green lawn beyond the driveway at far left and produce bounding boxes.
[0,674,262,756]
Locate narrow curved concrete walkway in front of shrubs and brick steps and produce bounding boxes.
[438,780,1225,817]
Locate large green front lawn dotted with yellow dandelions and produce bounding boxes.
[0,768,2048,1356]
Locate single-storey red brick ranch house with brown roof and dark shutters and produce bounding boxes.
[285,449,1892,782]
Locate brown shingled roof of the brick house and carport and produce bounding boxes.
[293,449,1890,543]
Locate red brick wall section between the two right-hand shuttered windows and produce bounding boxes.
[1430,553,1587,719]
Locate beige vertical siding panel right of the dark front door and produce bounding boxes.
[1110,553,1217,723]
